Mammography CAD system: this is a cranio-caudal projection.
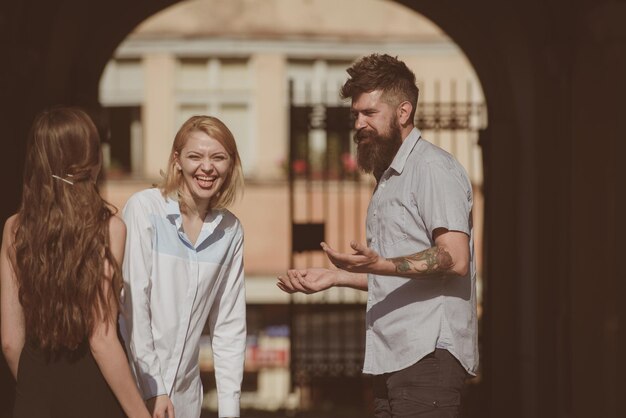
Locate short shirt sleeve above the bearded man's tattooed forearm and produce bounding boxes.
[415,161,472,238]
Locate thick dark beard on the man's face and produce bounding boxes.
[354,119,402,180]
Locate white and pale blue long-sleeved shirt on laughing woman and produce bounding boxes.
[120,189,246,418]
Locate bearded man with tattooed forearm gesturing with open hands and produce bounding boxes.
[277,54,478,418]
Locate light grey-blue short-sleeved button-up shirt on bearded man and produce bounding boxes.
[363,129,478,374]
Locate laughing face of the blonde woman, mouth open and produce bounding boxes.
[175,131,232,209]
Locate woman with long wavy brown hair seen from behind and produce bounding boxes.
[0,107,150,418]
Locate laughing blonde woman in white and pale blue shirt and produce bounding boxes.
[120,116,246,418]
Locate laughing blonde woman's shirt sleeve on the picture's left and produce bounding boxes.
[122,196,167,399]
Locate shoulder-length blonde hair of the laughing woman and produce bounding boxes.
[158,116,243,211]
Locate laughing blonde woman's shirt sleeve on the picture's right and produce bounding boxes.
[209,223,246,417]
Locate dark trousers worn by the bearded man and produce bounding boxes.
[374,349,467,418]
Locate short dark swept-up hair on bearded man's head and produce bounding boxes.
[340,54,419,120]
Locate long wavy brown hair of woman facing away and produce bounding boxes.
[13,107,121,352]
